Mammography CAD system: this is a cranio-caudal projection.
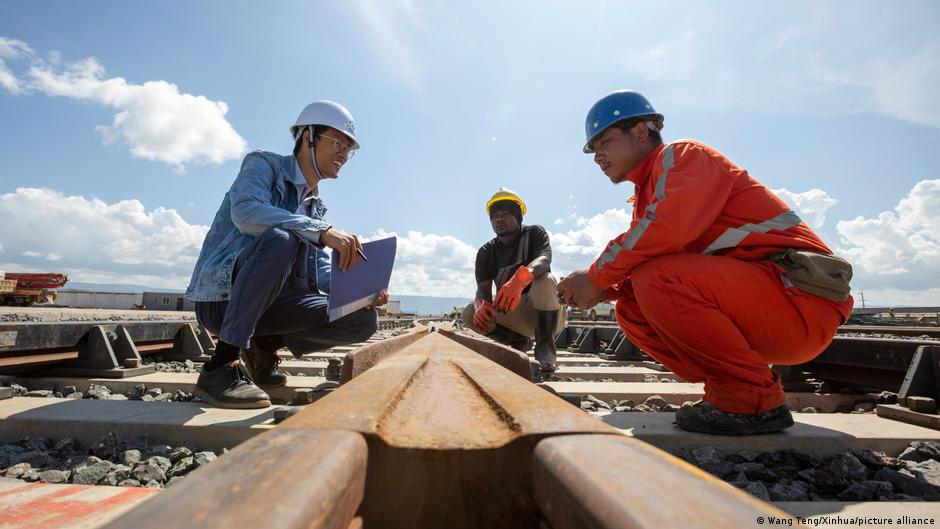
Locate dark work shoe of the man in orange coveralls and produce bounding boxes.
[676,400,793,435]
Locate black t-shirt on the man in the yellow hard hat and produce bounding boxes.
[476,225,552,292]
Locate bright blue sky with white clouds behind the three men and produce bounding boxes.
[0,0,940,305]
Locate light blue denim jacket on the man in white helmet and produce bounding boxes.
[186,151,330,301]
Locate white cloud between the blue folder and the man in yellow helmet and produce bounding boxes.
[369,229,477,297]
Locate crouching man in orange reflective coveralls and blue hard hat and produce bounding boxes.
[558,90,853,435]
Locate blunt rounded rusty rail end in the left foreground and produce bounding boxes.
[105,429,367,529]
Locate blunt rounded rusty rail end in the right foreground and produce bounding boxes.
[532,435,804,529]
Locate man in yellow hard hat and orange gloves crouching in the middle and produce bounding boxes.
[462,188,565,374]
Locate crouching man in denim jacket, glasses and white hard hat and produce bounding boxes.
[186,101,388,408]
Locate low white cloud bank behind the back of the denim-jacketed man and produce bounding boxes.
[0,188,208,288]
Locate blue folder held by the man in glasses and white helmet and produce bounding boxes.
[327,236,398,322]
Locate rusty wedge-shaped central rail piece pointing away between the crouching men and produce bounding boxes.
[280,333,617,449]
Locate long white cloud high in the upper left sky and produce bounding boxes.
[0,37,246,171]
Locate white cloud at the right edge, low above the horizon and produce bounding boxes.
[837,180,940,296]
